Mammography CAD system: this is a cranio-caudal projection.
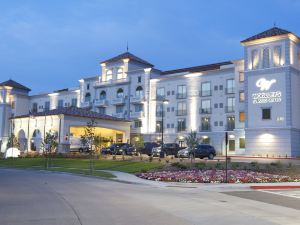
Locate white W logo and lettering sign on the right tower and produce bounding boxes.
[252,78,282,104]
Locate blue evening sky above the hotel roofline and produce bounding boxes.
[0,0,300,94]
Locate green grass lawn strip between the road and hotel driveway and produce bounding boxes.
[0,158,162,178]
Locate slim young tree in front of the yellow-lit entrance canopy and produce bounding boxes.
[80,119,97,174]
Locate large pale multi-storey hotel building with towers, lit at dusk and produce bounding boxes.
[0,27,300,157]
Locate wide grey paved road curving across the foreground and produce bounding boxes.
[0,169,300,225]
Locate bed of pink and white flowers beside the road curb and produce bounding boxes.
[137,170,300,183]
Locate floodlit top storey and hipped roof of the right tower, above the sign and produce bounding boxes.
[241,27,300,71]
